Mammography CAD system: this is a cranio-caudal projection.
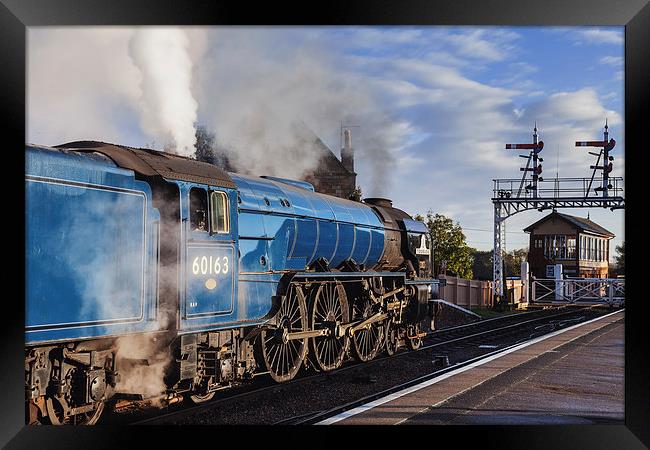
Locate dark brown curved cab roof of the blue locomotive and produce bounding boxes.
[55,141,236,189]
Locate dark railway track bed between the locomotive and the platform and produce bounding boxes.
[110,308,599,425]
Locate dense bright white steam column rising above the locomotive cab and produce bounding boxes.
[129,28,198,156]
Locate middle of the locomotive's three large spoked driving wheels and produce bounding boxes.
[310,281,350,371]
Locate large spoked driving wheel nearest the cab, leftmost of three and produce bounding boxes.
[260,285,307,383]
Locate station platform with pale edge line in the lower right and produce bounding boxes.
[320,310,625,425]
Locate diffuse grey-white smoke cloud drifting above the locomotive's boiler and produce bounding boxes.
[191,27,404,196]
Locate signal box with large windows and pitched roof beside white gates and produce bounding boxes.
[524,211,614,278]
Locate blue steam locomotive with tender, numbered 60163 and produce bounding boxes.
[25,141,439,424]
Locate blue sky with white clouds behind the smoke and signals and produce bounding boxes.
[27,26,625,260]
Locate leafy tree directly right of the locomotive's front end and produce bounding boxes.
[416,210,473,278]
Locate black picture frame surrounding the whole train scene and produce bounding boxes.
[0,0,650,449]
